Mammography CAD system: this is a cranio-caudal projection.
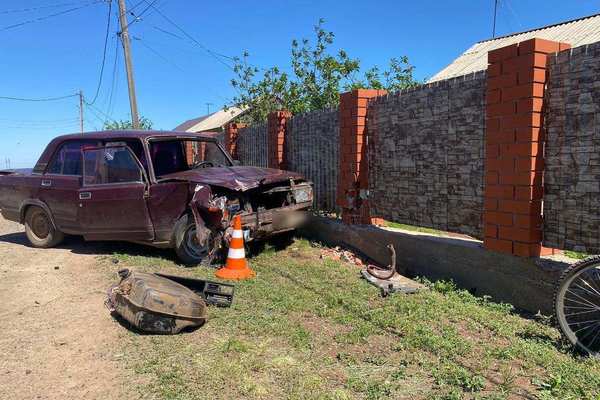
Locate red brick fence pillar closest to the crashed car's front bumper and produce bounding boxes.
[336,89,386,224]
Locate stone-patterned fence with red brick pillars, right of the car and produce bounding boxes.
[227,39,600,256]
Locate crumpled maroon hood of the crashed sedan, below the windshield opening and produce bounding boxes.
[161,166,304,191]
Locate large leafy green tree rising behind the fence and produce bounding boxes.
[231,19,418,122]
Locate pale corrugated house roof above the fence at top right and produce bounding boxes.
[429,14,600,82]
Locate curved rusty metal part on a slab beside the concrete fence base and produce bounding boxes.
[360,244,426,297]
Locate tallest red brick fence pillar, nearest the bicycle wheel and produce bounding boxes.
[483,39,570,257]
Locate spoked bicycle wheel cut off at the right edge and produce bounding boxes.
[554,256,600,358]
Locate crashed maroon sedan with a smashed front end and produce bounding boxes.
[0,131,313,264]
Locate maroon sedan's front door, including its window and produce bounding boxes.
[78,146,154,241]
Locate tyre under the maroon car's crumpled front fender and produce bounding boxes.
[174,214,212,266]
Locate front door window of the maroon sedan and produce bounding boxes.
[83,147,144,186]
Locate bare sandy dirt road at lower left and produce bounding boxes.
[0,217,139,399]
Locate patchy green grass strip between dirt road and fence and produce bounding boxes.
[106,240,600,399]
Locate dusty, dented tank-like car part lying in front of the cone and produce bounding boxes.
[106,269,206,334]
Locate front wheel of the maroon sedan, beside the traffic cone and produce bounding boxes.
[175,214,218,266]
